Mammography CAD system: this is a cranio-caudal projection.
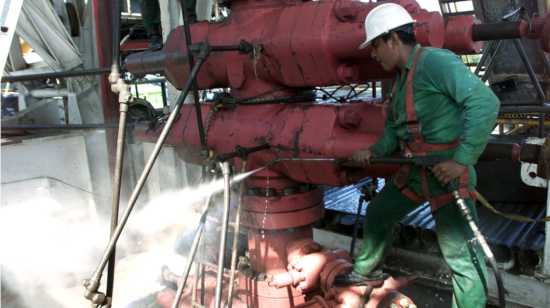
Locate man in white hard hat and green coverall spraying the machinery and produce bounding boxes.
[334,4,499,308]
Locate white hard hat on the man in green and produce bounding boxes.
[359,3,416,49]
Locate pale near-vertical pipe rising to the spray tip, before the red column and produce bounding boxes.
[216,162,231,308]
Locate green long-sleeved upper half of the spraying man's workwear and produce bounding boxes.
[370,45,500,195]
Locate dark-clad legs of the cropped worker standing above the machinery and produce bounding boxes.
[139,0,197,50]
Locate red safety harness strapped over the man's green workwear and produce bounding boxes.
[382,48,476,213]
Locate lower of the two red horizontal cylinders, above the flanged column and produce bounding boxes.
[135,101,397,185]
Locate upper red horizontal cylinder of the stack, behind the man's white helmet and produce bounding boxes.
[126,0,477,98]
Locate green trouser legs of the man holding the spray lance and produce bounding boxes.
[354,178,488,308]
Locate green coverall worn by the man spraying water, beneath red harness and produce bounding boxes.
[354,45,499,308]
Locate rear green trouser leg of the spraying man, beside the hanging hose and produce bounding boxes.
[433,199,487,308]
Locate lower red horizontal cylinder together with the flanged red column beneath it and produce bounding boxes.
[136,101,406,308]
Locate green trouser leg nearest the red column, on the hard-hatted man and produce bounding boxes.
[354,178,422,277]
